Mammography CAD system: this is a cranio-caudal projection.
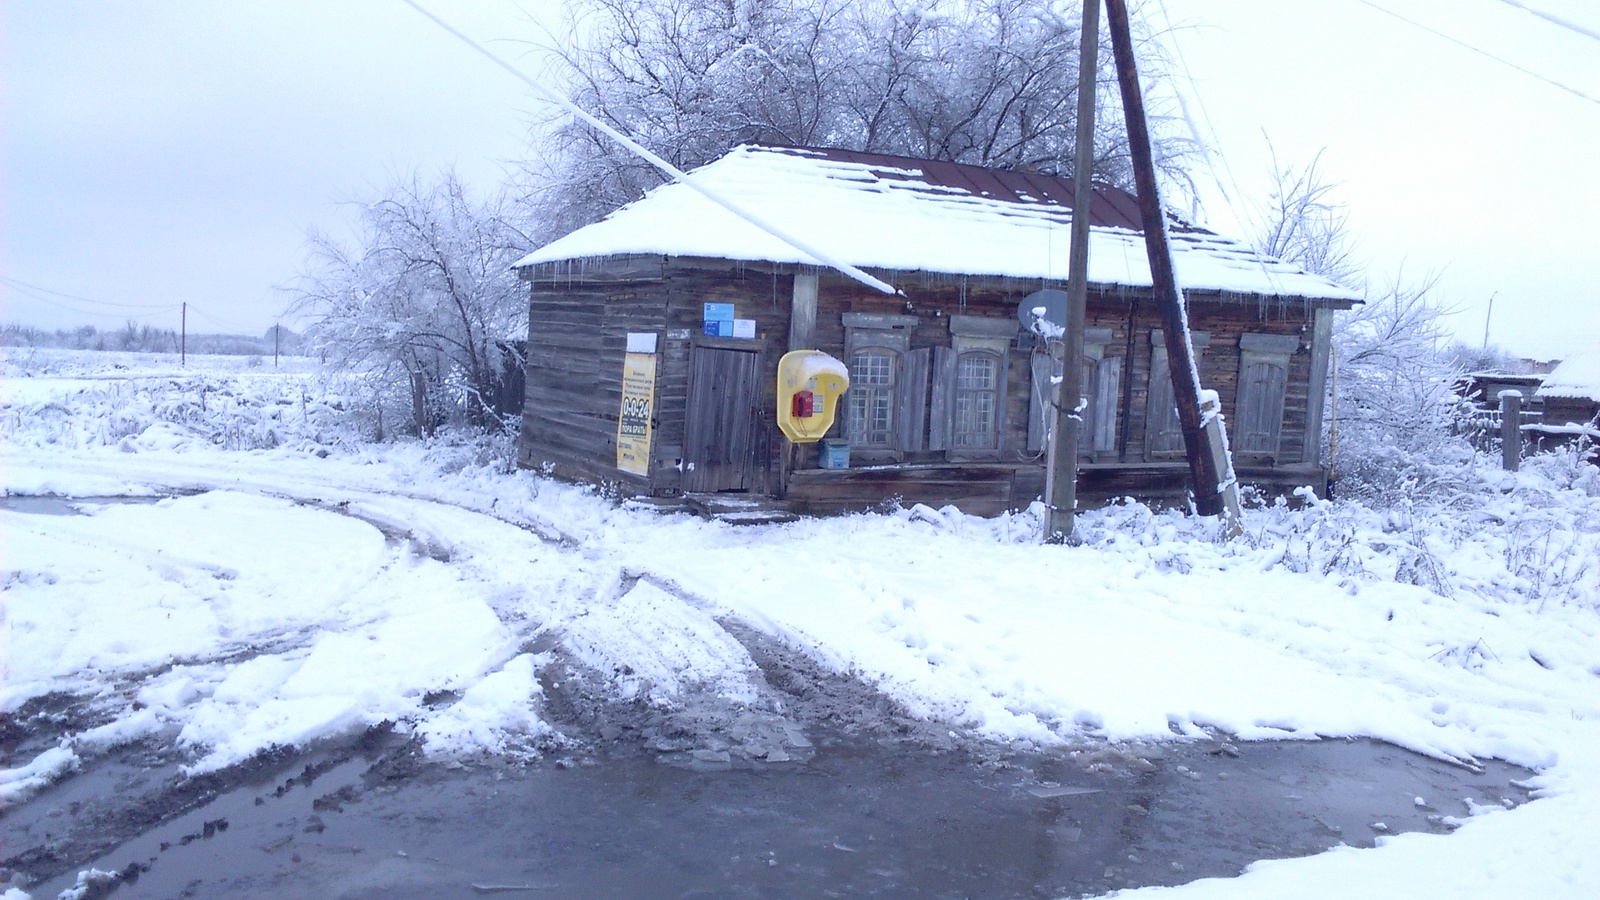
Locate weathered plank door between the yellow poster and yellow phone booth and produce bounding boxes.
[683,346,765,493]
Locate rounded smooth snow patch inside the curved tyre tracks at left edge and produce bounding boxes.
[0,492,389,711]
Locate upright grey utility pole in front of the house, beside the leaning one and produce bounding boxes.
[1045,0,1099,541]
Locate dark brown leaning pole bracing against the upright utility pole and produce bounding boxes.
[1106,0,1232,516]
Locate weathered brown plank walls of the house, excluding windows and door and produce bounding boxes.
[518,259,1337,511]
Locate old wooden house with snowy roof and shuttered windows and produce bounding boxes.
[518,146,1357,514]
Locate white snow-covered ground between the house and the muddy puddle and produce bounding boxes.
[9,351,1600,897]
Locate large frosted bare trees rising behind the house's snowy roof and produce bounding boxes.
[528,0,1187,232]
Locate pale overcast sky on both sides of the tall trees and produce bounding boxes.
[0,0,1600,357]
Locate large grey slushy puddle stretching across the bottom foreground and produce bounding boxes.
[18,737,1528,898]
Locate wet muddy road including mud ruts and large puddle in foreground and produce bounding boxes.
[0,634,1528,898]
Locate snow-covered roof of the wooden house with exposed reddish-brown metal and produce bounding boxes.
[517,146,1360,301]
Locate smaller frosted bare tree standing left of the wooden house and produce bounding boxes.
[296,173,531,434]
